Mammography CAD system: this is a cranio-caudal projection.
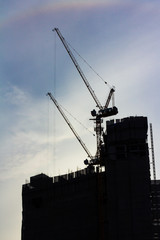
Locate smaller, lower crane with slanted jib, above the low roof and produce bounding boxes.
[47,92,96,164]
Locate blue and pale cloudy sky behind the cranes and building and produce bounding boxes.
[0,0,160,240]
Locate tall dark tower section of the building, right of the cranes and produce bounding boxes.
[105,117,152,240]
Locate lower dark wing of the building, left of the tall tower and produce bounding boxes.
[22,170,103,240]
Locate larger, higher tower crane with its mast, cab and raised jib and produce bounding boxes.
[53,28,118,164]
